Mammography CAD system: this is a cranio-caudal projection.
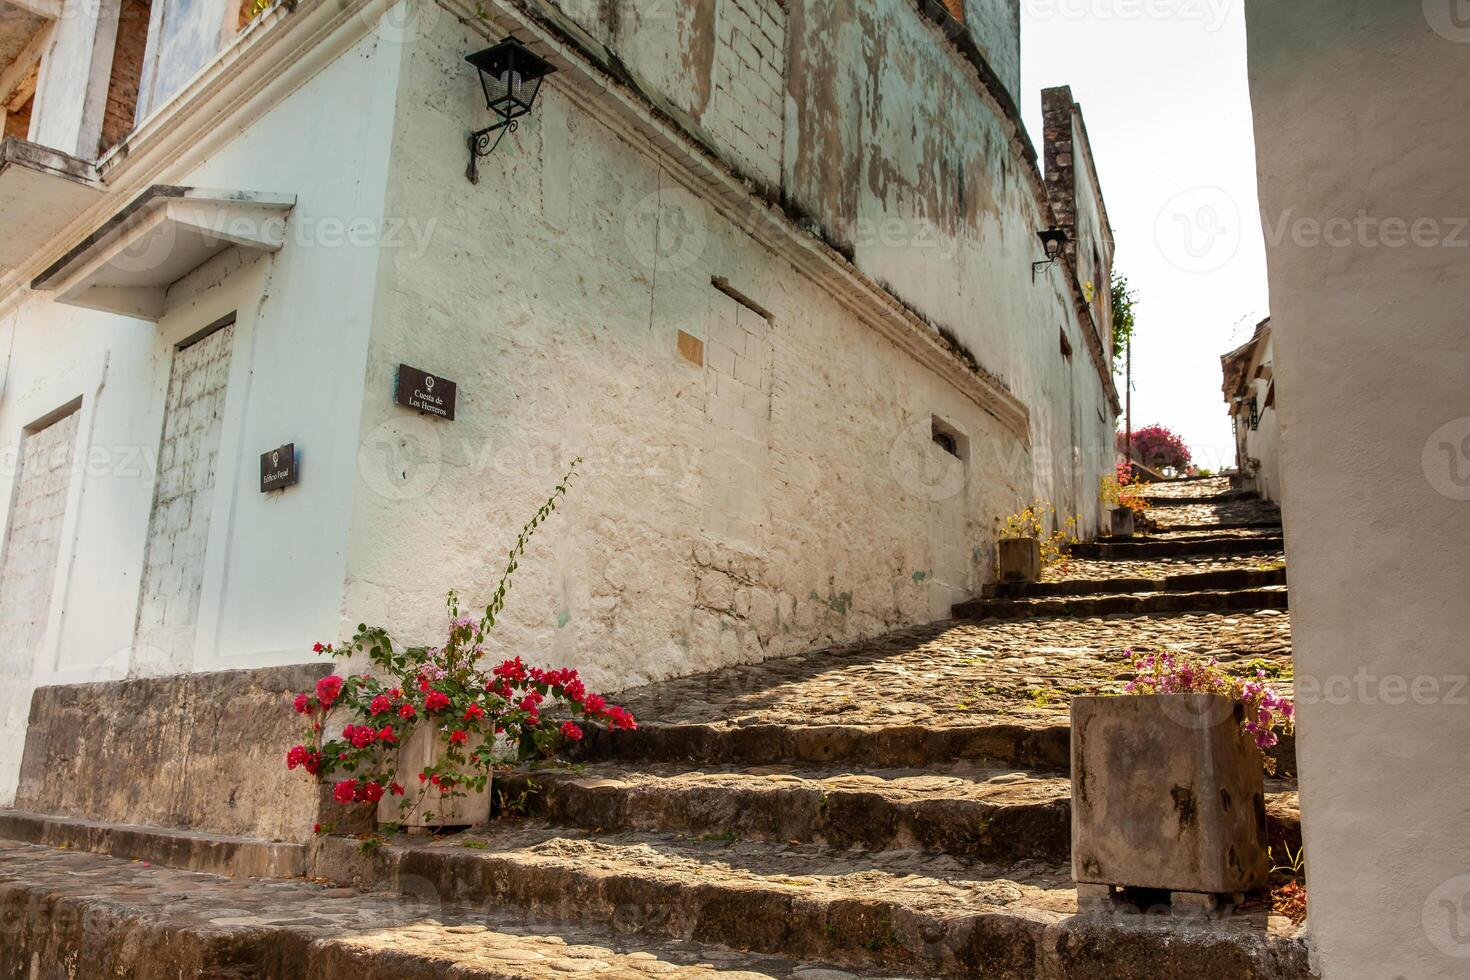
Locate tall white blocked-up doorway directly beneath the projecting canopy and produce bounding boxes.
[129,325,235,676]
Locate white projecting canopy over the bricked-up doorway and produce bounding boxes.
[31,184,295,320]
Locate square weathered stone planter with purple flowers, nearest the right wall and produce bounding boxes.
[1072,693,1270,911]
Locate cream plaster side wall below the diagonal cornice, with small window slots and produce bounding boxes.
[345,11,1034,686]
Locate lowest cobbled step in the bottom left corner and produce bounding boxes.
[0,840,892,980]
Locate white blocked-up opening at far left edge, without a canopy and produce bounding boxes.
[0,411,81,786]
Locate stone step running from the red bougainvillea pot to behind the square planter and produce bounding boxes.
[497,764,1301,864]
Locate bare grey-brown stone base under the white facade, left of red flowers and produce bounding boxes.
[16,663,329,840]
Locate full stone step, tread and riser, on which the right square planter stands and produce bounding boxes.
[315,821,1310,980]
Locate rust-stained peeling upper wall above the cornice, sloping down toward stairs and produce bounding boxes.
[785,0,1113,527]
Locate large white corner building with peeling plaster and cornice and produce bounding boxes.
[0,0,1117,801]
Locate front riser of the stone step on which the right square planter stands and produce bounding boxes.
[310,837,1311,980]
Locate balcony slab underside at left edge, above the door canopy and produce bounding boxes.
[0,137,106,270]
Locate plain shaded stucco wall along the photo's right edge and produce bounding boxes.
[1247,0,1470,980]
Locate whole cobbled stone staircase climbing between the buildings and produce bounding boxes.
[0,482,1311,980]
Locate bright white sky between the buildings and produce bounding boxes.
[1020,0,1269,469]
